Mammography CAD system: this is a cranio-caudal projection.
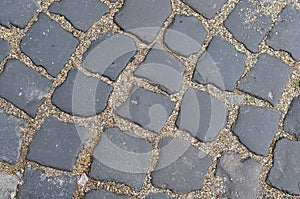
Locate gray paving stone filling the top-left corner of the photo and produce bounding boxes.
[0,0,39,28]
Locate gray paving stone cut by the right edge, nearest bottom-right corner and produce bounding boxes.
[267,139,300,195]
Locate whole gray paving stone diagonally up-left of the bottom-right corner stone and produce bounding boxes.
[233,106,281,156]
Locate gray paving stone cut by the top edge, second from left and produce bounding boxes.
[49,0,109,31]
